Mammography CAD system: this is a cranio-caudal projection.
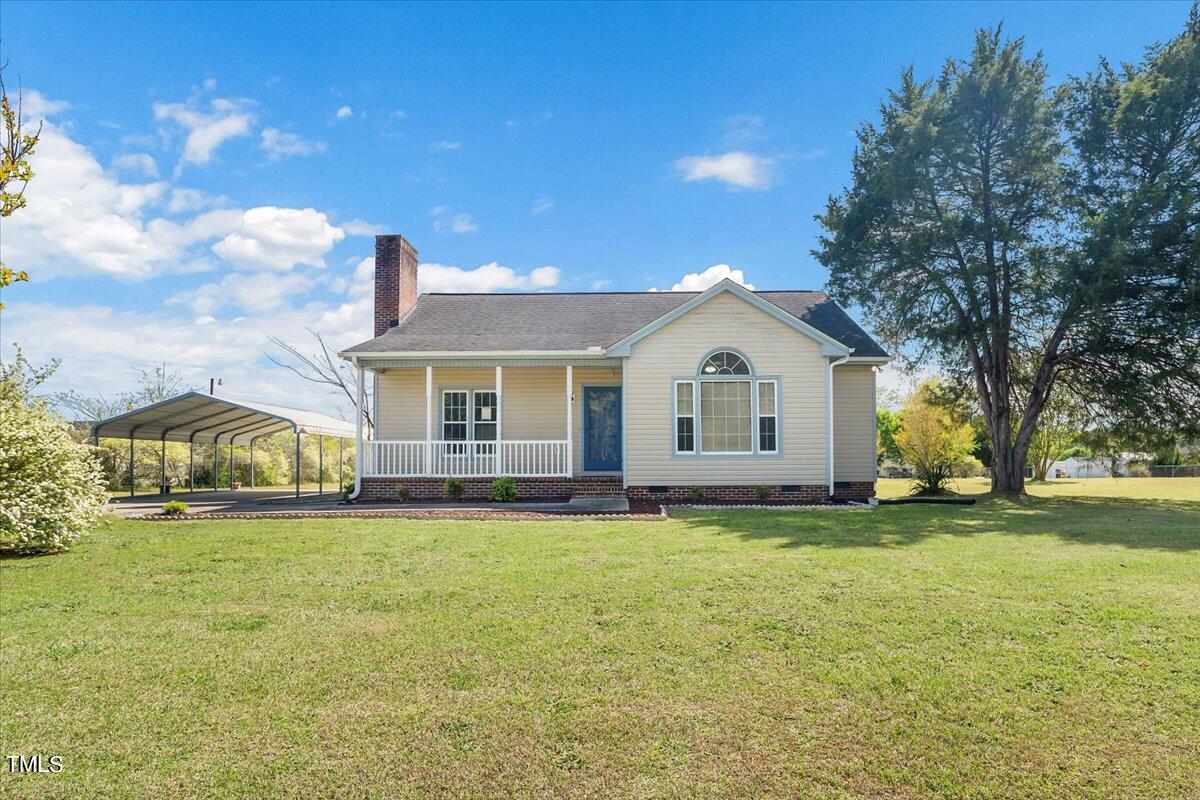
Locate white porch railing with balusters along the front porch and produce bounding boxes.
[362,439,571,477]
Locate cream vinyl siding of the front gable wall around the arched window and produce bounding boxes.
[625,294,828,486]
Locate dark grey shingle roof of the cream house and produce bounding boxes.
[346,291,887,356]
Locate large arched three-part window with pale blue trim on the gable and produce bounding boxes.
[673,350,779,455]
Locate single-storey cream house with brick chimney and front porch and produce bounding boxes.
[341,235,888,501]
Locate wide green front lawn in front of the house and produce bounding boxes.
[7,485,1200,799]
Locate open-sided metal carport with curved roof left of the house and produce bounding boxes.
[91,392,355,497]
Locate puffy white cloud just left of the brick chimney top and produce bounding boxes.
[212,205,346,271]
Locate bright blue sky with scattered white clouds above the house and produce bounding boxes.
[0,0,1188,407]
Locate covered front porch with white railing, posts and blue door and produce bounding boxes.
[360,359,623,482]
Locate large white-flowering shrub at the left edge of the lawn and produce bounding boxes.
[0,354,108,553]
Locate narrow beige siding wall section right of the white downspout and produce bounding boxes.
[833,365,875,481]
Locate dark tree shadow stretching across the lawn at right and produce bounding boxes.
[672,497,1200,551]
